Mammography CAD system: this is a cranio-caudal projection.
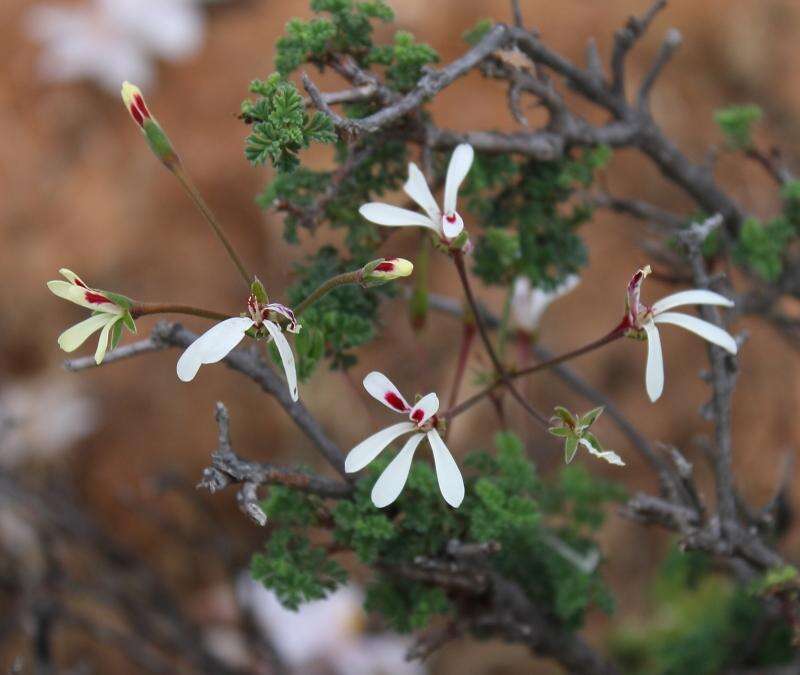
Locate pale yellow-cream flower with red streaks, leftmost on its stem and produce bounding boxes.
[47,268,136,365]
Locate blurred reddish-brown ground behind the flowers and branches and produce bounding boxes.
[0,0,800,674]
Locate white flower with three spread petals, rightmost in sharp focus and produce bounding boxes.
[623,265,737,402]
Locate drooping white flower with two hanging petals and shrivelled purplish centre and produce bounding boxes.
[177,296,300,401]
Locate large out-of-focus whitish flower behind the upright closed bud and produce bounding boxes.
[27,0,205,92]
